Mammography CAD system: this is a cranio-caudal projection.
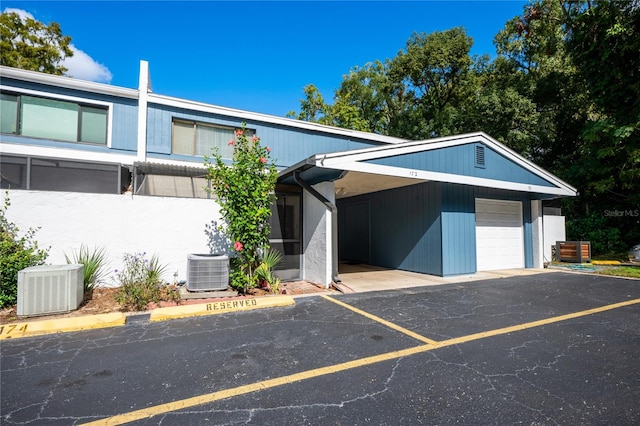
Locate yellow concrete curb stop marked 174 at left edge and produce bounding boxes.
[0,312,126,340]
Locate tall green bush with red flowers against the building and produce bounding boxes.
[205,124,278,293]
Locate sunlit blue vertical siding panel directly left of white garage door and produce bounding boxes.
[441,184,476,276]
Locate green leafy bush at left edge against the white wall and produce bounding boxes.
[0,192,48,308]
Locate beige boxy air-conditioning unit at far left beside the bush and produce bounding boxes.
[17,264,84,317]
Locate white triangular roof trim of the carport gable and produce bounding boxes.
[279,132,578,196]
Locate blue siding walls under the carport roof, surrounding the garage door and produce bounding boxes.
[337,182,533,276]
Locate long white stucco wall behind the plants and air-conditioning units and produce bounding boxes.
[2,191,223,285]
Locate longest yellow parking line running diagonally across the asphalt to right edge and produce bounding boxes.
[80,299,640,425]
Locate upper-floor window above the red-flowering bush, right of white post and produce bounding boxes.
[171,120,255,158]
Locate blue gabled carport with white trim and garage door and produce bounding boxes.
[279,133,576,285]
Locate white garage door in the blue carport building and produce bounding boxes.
[476,198,524,271]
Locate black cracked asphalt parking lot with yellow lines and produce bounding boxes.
[0,273,640,425]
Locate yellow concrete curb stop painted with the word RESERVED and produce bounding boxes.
[149,296,296,321]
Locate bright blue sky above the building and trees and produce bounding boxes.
[2,0,528,116]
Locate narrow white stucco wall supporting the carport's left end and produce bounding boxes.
[302,182,335,286]
